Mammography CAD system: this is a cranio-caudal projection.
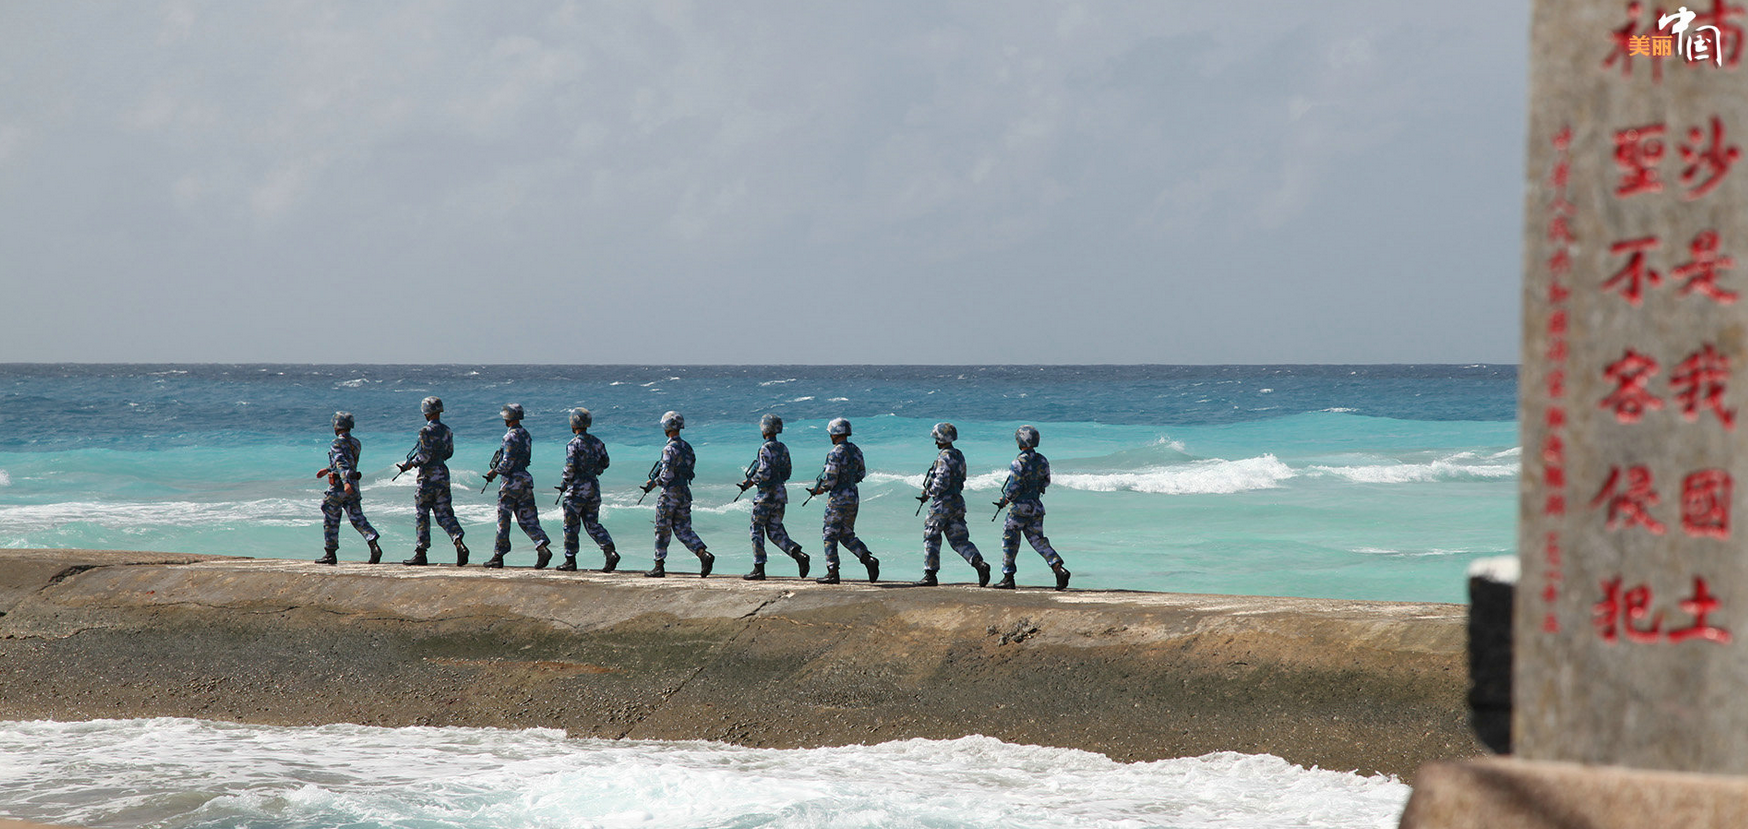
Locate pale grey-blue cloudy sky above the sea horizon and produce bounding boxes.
[0,0,1530,364]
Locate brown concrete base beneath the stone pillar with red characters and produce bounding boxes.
[1402,757,1748,829]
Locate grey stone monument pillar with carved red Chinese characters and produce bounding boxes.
[1512,0,1748,775]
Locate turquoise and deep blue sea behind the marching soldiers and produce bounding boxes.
[0,366,1519,602]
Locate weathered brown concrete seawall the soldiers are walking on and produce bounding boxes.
[0,551,1481,778]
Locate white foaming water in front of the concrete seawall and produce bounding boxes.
[0,719,1409,829]
